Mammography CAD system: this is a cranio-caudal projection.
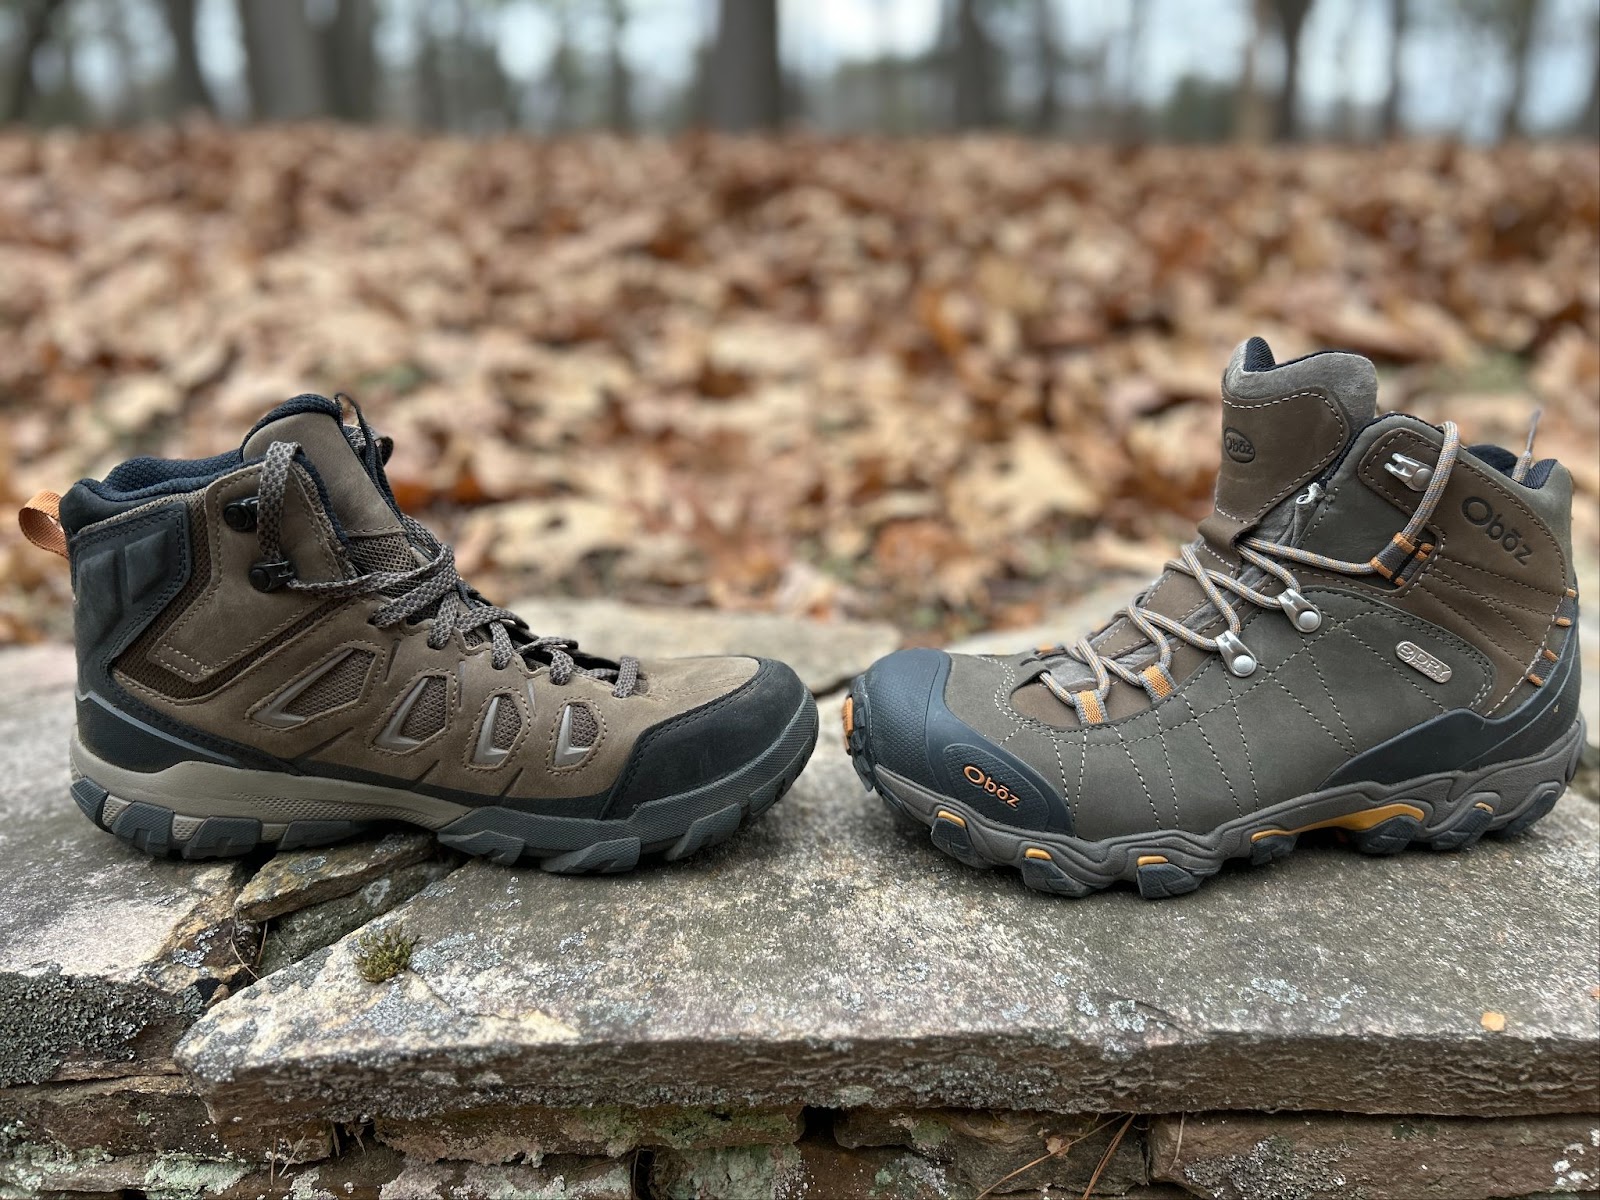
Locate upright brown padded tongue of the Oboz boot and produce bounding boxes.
[1200,338,1378,549]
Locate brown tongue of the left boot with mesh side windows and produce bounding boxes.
[240,395,416,570]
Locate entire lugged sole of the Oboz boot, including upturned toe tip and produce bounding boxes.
[843,678,1586,899]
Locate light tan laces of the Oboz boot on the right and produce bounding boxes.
[1040,421,1461,725]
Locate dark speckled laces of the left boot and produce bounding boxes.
[256,442,638,699]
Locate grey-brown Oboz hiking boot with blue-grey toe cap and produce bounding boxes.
[845,338,1584,898]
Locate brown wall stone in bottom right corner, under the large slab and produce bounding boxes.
[1149,1112,1600,1200]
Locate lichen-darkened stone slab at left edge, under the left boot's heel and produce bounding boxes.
[0,646,254,1086]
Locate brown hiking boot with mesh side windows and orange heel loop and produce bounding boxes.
[22,395,816,872]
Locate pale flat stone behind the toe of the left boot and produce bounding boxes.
[510,598,901,696]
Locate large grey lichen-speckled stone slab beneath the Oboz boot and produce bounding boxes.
[179,720,1600,1118]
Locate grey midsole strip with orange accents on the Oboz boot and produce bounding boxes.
[875,718,1584,874]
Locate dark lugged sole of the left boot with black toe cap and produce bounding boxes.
[70,696,818,875]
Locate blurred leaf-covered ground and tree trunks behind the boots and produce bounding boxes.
[0,0,1600,642]
